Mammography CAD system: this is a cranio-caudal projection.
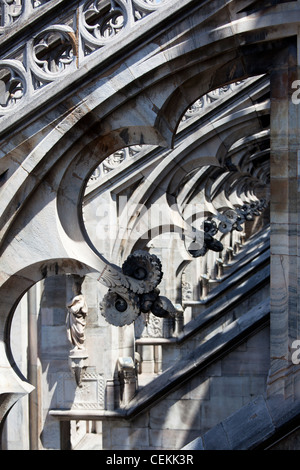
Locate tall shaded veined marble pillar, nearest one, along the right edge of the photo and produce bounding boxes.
[267,42,300,398]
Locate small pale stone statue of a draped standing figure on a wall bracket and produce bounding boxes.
[66,293,88,351]
